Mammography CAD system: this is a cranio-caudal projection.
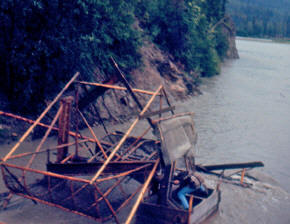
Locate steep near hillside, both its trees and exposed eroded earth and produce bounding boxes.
[0,0,238,142]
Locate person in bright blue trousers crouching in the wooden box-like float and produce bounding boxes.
[173,171,208,209]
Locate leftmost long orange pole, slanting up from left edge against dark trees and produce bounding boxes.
[0,72,80,164]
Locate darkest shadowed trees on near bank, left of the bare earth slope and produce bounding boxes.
[0,0,140,112]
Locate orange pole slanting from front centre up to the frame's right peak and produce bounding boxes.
[90,85,162,184]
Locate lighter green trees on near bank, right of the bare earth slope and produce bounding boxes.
[136,0,226,76]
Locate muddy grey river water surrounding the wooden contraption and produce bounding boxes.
[0,40,290,224]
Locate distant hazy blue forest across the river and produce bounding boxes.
[227,0,290,38]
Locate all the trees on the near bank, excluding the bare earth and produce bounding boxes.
[0,0,227,113]
